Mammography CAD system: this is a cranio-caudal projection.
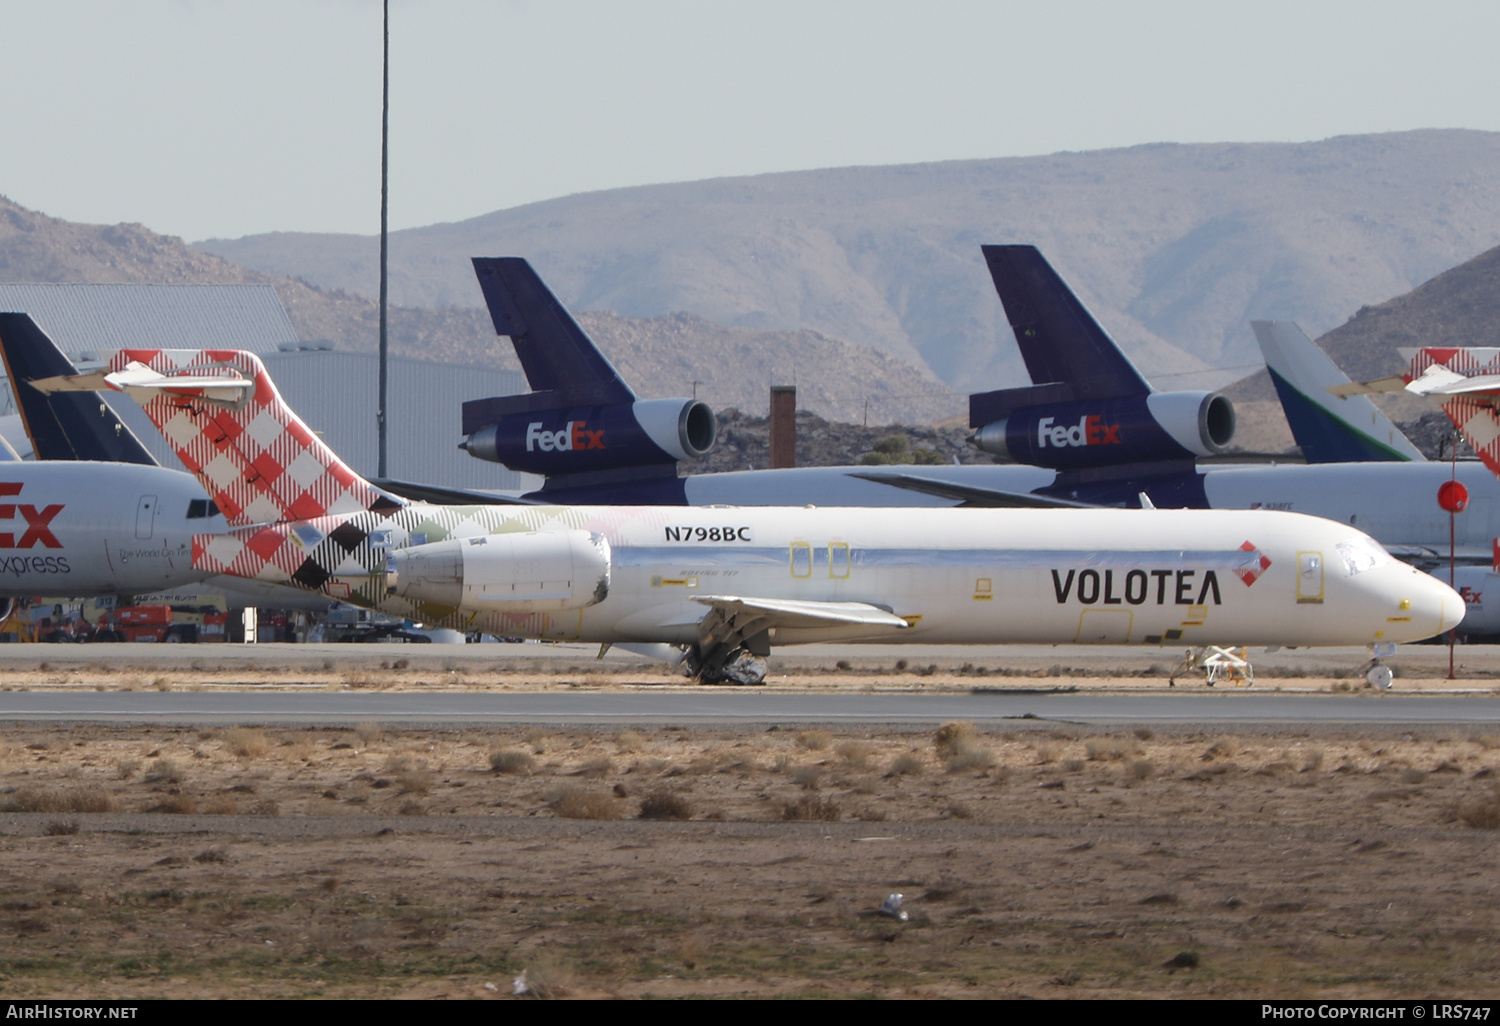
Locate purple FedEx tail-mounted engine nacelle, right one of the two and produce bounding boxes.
[972,392,1235,470]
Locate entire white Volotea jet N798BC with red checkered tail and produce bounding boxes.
[33,350,1461,681]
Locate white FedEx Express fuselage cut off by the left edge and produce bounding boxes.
[0,462,225,599]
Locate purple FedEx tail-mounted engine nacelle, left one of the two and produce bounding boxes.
[461,399,719,476]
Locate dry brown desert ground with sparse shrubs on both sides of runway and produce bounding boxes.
[0,647,1500,999]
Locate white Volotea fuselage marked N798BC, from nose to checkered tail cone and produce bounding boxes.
[205,504,1463,645]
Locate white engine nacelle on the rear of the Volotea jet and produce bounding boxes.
[386,531,609,612]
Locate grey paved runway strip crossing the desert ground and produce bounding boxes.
[0,689,1500,729]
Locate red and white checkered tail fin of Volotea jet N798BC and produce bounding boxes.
[110,350,407,527]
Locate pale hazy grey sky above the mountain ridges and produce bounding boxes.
[0,0,1500,240]
